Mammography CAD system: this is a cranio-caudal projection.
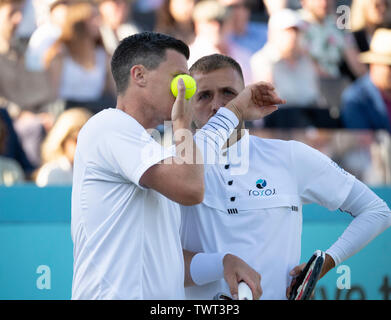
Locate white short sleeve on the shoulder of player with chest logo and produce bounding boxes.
[291,141,355,210]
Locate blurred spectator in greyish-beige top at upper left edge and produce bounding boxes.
[0,0,54,166]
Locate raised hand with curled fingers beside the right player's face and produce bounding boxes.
[226,81,286,121]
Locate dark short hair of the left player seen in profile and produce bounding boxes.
[111,32,190,94]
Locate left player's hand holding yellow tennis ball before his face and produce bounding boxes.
[171,79,193,128]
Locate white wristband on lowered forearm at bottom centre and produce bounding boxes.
[190,252,227,286]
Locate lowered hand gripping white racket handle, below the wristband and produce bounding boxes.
[223,254,262,300]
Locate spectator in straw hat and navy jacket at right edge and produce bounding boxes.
[342,28,391,132]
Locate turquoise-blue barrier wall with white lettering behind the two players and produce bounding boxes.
[0,185,391,299]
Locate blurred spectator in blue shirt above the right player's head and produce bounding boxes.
[219,0,267,54]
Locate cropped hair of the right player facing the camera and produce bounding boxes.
[189,53,244,82]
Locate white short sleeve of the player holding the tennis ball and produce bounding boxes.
[99,115,175,188]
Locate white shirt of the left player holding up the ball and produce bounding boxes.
[71,109,184,299]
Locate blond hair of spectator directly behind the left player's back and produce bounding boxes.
[41,108,92,163]
